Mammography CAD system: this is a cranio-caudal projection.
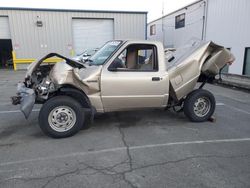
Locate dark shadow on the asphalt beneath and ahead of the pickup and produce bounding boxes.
[0,109,189,140]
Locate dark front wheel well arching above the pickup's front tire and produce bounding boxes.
[56,85,91,108]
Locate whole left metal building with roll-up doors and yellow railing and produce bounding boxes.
[0,7,147,69]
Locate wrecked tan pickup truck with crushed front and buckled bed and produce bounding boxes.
[12,40,234,138]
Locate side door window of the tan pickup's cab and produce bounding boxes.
[109,44,158,71]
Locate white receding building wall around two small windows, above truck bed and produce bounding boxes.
[147,1,205,47]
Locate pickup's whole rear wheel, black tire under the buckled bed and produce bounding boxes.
[183,89,216,122]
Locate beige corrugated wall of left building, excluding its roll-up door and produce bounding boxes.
[0,8,147,59]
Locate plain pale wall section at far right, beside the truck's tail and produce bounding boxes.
[206,0,250,74]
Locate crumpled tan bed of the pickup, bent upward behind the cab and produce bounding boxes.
[165,41,234,100]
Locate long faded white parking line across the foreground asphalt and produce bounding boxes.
[0,138,250,166]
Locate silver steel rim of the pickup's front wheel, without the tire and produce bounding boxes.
[48,106,76,132]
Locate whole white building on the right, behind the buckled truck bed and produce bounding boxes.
[147,0,250,75]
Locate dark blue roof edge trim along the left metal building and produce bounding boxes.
[0,7,148,14]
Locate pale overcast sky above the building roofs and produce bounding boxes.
[0,0,196,22]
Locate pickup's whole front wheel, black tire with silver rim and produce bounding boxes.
[39,96,85,138]
